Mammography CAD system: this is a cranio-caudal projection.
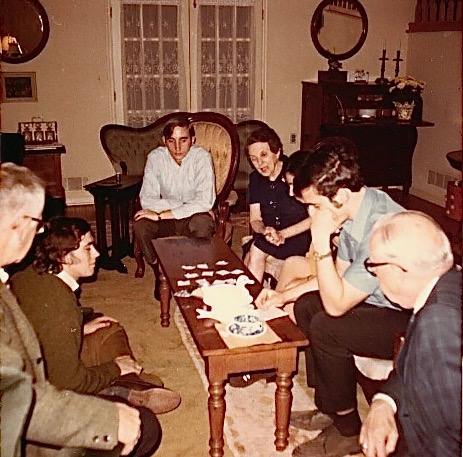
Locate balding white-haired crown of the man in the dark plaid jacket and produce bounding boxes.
[372,210,453,272]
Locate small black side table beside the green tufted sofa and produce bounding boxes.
[85,175,143,273]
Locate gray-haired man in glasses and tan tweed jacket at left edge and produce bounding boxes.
[0,163,140,457]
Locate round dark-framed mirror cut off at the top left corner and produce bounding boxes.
[0,0,50,63]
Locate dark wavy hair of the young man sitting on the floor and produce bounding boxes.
[33,217,91,274]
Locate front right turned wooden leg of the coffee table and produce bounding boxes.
[275,372,293,451]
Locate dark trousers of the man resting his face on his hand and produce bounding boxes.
[294,291,411,414]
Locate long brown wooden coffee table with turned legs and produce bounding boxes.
[153,237,308,457]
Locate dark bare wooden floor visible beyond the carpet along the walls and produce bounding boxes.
[65,189,462,265]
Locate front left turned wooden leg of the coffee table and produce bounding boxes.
[208,380,225,457]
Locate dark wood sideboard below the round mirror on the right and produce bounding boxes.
[300,81,434,197]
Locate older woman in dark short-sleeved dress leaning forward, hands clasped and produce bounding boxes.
[244,127,310,281]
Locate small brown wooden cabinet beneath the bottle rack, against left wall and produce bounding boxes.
[23,144,66,203]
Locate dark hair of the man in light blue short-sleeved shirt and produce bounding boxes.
[293,141,363,200]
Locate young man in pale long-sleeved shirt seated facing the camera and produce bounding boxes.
[134,117,216,300]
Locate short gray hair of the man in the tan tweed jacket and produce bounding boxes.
[0,162,45,219]
